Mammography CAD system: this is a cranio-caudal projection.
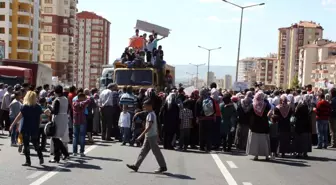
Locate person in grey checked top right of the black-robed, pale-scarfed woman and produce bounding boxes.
[179,100,193,151]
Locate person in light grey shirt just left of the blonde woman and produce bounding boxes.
[9,92,22,146]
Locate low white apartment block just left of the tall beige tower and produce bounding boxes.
[238,58,257,86]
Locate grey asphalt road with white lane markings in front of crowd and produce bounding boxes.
[0,132,336,185]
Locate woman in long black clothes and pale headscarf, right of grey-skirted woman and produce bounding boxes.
[273,94,293,157]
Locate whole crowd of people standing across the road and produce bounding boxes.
[0,83,336,172]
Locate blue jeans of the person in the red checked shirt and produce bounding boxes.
[72,124,86,154]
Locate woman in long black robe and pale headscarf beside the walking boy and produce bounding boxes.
[160,93,180,150]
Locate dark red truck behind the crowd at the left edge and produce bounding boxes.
[0,59,52,87]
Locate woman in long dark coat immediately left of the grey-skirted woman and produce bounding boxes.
[235,91,252,151]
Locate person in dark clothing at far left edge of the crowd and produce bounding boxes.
[0,86,14,131]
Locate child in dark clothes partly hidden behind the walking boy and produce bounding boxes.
[132,109,147,147]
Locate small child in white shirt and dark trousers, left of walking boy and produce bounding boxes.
[118,105,131,145]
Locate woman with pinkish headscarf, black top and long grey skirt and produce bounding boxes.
[246,92,271,160]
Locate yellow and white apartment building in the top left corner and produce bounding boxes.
[0,0,40,62]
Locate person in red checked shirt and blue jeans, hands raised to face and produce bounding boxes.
[72,93,91,157]
